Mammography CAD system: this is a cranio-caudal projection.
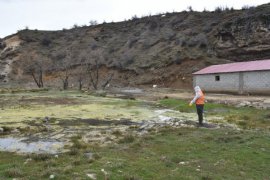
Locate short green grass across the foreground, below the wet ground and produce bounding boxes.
[0,128,270,180]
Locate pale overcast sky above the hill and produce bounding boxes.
[0,0,269,38]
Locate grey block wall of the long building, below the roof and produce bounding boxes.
[193,71,270,94]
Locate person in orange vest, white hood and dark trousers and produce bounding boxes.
[189,86,204,126]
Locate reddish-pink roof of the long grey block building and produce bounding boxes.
[193,59,270,75]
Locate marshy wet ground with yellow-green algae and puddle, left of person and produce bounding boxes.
[0,90,234,154]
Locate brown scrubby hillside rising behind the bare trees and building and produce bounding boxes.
[0,4,270,88]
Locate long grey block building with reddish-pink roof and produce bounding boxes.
[193,60,270,94]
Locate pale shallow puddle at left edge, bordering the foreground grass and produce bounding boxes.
[0,137,64,154]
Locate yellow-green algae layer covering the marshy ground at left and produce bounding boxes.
[0,93,158,126]
